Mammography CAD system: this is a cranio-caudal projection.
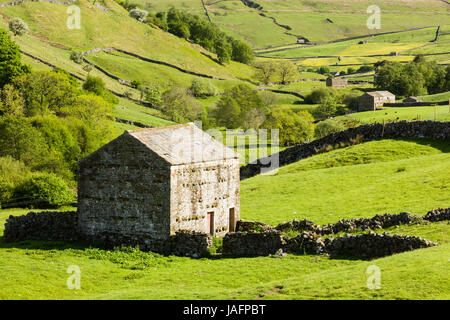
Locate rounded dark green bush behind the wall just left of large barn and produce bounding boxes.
[13,173,75,209]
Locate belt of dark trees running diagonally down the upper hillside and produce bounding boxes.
[122,3,254,64]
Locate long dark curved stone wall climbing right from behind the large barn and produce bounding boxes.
[240,121,450,180]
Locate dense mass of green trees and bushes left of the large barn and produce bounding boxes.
[0,31,114,207]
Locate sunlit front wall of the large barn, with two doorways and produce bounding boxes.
[170,159,239,237]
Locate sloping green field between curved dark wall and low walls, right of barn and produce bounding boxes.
[241,141,450,224]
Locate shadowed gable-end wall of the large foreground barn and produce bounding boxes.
[78,135,170,241]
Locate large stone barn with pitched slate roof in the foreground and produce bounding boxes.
[78,123,240,250]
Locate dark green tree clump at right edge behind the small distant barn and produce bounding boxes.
[375,56,450,96]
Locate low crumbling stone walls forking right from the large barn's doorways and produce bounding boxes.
[223,208,450,258]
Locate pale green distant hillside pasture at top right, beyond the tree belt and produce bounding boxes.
[149,0,450,49]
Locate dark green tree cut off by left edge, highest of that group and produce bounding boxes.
[0,30,31,88]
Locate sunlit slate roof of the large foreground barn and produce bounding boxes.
[124,123,239,165]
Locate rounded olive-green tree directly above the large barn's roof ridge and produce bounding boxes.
[162,87,202,123]
